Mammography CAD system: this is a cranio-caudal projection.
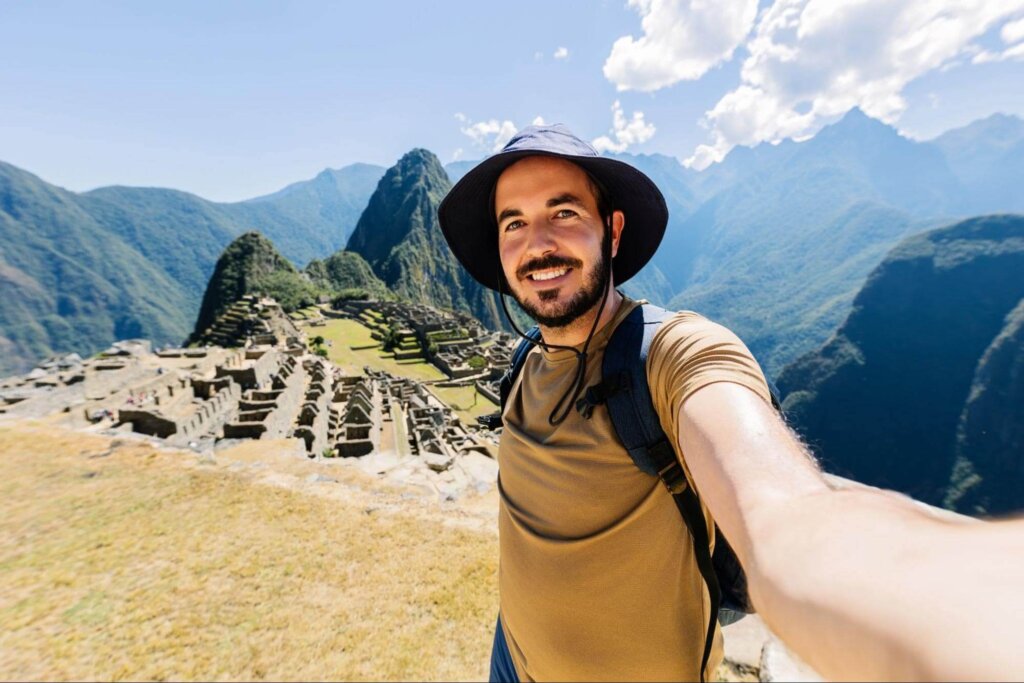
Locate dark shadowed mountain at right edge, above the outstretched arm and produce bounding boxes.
[778,215,1024,507]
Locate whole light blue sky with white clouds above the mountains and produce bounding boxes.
[0,0,1024,201]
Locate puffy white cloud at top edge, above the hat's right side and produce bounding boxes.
[604,0,758,92]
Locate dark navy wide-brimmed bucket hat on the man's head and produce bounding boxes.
[437,124,669,292]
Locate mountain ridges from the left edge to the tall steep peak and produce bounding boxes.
[0,163,383,375]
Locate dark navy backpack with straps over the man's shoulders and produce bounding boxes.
[479,303,780,683]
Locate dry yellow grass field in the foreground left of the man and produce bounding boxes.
[0,423,498,680]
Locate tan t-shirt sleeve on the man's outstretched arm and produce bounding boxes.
[647,311,771,481]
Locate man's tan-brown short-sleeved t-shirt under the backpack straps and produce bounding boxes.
[498,299,770,681]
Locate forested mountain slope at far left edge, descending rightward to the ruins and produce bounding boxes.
[0,163,189,376]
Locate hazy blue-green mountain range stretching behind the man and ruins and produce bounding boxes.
[0,110,1024,376]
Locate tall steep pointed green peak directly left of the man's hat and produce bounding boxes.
[346,150,504,328]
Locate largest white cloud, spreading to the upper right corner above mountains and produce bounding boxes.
[686,0,1024,168]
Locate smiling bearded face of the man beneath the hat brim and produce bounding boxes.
[495,157,624,328]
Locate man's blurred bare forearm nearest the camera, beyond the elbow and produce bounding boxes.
[748,490,1024,680]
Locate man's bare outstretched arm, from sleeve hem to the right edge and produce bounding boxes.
[678,382,1024,680]
